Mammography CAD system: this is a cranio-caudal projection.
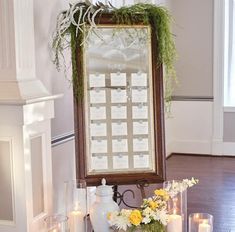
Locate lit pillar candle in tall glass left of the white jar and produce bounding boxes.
[69,210,85,232]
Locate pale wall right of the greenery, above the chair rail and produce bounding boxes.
[171,0,213,97]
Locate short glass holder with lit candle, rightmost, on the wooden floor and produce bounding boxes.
[189,213,213,232]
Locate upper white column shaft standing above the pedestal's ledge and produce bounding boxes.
[0,0,50,103]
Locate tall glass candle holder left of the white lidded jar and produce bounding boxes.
[65,180,87,232]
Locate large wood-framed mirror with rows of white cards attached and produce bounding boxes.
[75,14,165,185]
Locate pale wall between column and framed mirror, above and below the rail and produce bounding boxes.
[34,0,75,215]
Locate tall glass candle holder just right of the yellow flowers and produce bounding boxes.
[163,180,187,232]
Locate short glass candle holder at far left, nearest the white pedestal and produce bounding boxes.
[44,215,69,232]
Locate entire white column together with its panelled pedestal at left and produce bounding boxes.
[0,0,62,232]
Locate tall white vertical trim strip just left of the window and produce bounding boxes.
[212,0,225,155]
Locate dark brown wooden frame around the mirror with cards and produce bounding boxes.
[74,13,165,186]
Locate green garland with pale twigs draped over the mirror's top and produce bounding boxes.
[52,1,176,102]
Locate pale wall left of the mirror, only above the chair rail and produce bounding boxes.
[34,0,73,137]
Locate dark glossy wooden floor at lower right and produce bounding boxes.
[167,154,235,232]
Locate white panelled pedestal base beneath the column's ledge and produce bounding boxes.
[0,98,60,232]
